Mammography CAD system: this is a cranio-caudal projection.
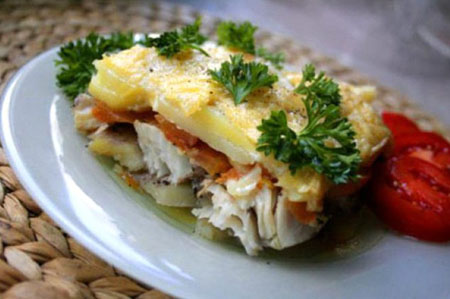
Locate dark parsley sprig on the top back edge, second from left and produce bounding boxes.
[142,18,209,58]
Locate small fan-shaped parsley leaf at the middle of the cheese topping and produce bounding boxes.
[209,54,278,105]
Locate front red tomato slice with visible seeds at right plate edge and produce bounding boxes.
[367,156,450,242]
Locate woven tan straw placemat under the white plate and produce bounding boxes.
[0,1,449,299]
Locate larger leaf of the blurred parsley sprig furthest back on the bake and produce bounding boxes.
[217,21,258,54]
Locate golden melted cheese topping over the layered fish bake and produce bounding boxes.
[89,42,389,211]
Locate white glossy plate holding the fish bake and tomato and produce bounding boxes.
[1,49,450,298]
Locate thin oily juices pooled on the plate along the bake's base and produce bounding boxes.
[98,157,384,263]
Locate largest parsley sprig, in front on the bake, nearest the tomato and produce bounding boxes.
[257,65,361,184]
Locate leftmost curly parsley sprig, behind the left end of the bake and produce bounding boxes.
[55,33,134,99]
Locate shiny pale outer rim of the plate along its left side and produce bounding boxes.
[4,45,450,298]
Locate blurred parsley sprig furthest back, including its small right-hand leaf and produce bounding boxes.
[217,21,284,69]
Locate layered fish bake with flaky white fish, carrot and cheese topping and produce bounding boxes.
[75,42,390,255]
